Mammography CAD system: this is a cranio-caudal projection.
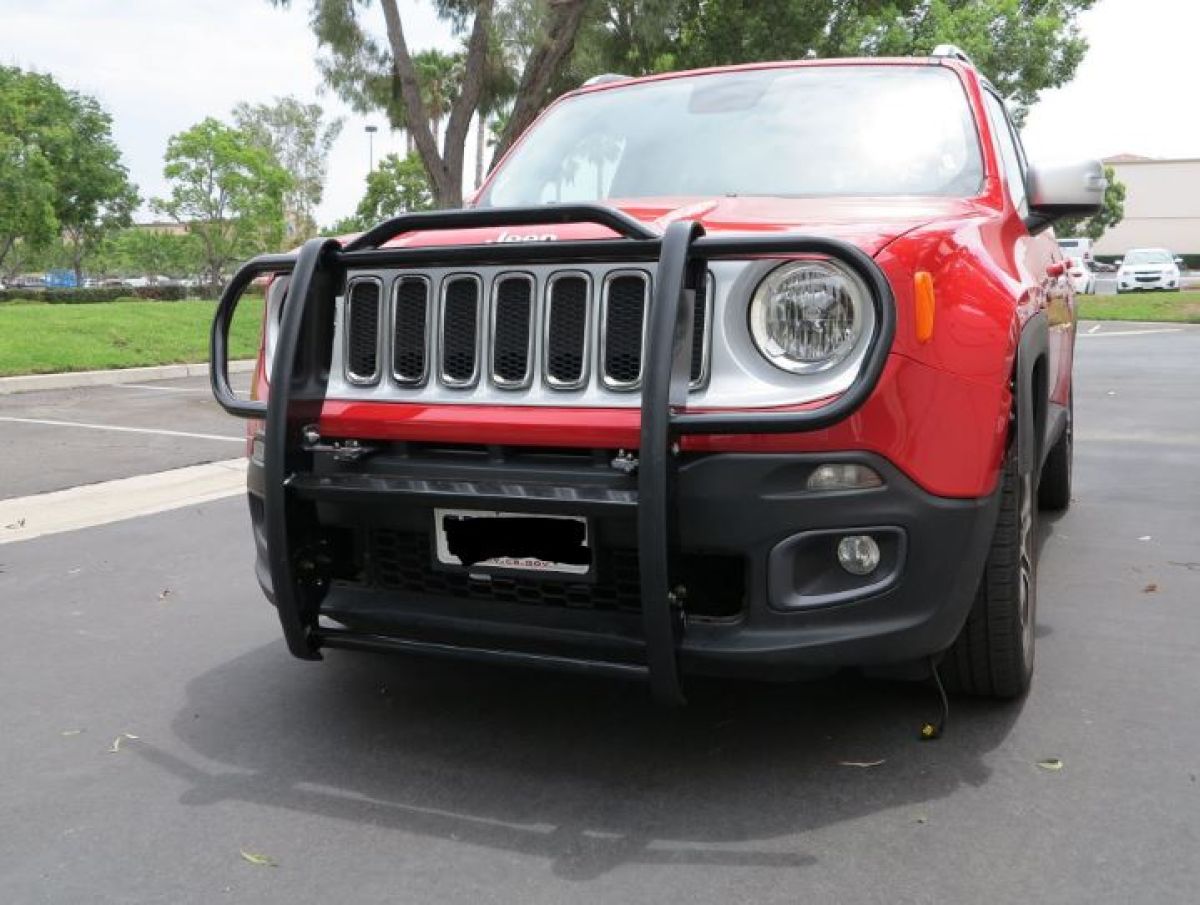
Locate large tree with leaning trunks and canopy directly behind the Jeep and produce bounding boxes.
[280,0,1096,206]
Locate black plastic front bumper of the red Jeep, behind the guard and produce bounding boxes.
[250,451,998,679]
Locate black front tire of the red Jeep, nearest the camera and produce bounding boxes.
[938,444,1038,699]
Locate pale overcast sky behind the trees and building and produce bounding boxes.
[0,0,1200,224]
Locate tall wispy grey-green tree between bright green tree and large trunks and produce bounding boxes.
[233,97,342,245]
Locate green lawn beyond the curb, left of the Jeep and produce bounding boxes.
[0,296,263,377]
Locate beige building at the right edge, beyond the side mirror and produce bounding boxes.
[1092,154,1200,259]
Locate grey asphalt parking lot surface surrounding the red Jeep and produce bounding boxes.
[0,323,1200,905]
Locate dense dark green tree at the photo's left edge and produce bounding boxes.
[0,67,138,278]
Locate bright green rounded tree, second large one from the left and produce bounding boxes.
[154,116,292,286]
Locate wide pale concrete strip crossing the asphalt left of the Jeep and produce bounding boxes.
[0,459,246,544]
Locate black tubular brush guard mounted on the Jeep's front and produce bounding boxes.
[210,204,895,703]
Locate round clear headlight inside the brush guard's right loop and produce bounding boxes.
[750,260,874,373]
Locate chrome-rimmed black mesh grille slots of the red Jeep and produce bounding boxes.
[344,268,713,391]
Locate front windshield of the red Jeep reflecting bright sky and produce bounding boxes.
[479,65,983,206]
